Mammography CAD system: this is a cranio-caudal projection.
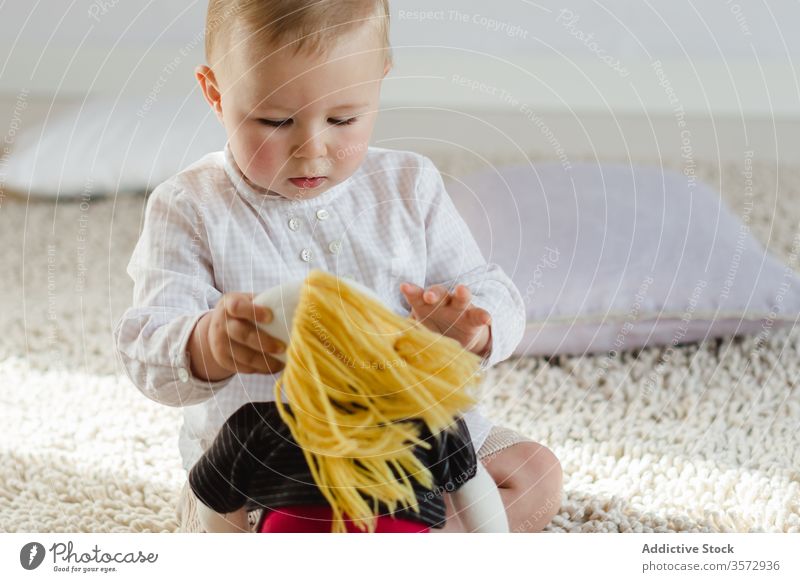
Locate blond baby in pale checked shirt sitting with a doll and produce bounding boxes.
[115,0,561,532]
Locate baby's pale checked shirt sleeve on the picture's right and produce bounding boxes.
[416,157,525,369]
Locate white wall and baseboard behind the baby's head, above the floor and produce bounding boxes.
[0,0,800,117]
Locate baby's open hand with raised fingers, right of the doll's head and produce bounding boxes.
[400,283,492,356]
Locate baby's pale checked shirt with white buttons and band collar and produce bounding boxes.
[115,145,525,471]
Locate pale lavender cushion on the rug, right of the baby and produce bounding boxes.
[449,163,800,355]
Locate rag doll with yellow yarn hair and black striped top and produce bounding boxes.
[189,270,508,532]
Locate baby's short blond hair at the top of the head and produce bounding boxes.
[205,0,392,66]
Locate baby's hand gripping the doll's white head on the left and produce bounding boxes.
[189,293,286,381]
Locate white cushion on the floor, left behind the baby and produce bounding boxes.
[5,94,226,199]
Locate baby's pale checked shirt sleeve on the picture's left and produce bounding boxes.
[114,182,230,406]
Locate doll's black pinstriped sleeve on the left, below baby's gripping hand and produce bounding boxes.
[188,402,285,513]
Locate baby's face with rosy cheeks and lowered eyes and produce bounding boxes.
[197,26,389,199]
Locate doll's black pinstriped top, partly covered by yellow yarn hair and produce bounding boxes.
[189,402,477,531]
